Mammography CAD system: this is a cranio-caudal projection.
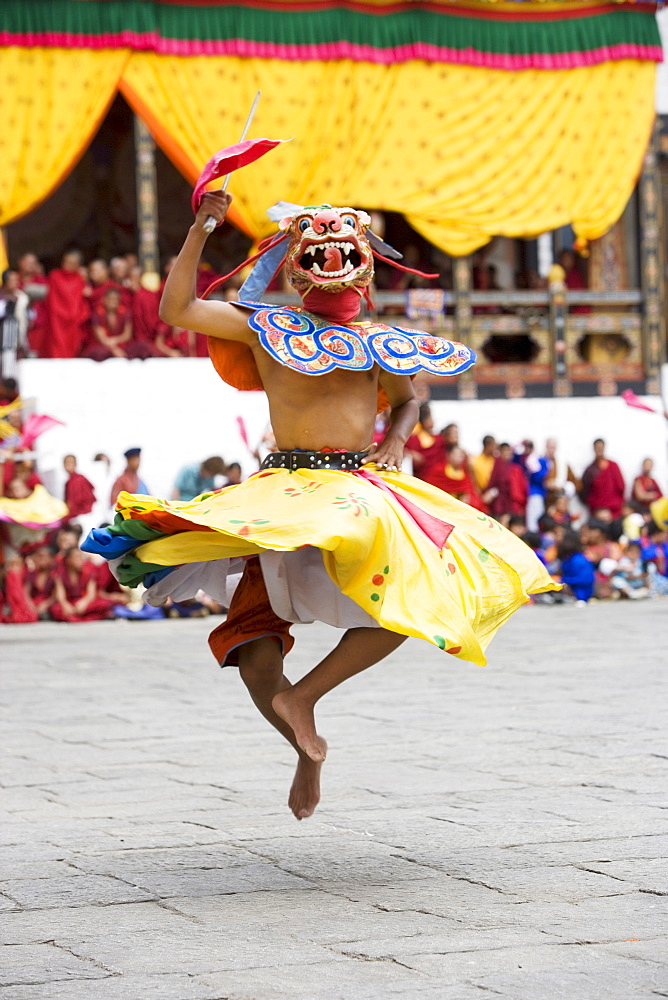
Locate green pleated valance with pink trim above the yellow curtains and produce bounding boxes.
[0,0,662,70]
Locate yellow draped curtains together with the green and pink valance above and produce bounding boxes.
[0,0,661,266]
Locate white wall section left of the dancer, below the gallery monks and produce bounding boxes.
[19,358,268,504]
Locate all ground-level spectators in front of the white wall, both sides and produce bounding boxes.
[0,379,668,623]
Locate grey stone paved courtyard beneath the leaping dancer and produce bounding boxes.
[0,601,668,1000]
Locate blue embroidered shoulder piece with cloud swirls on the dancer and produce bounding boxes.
[236,302,476,375]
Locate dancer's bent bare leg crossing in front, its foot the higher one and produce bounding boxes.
[272,628,406,761]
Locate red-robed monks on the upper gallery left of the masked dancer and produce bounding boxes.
[0,249,234,366]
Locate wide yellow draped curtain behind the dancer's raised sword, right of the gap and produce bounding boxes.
[121,52,655,254]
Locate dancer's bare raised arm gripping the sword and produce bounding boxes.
[160,191,252,343]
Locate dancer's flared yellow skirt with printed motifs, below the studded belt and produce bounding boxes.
[109,465,558,666]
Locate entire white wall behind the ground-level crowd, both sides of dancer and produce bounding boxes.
[19,358,668,504]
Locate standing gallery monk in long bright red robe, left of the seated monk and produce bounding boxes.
[46,250,90,358]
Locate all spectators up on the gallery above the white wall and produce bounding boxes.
[0,243,587,378]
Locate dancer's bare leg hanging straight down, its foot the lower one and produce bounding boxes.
[239,637,327,819]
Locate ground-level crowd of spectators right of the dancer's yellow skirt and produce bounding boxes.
[406,404,668,605]
